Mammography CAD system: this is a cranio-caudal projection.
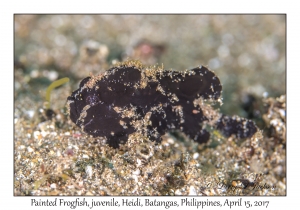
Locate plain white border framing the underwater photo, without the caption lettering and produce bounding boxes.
[0,0,300,209]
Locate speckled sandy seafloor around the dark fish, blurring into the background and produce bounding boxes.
[14,15,286,196]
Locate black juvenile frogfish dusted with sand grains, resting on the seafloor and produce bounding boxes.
[67,61,257,148]
